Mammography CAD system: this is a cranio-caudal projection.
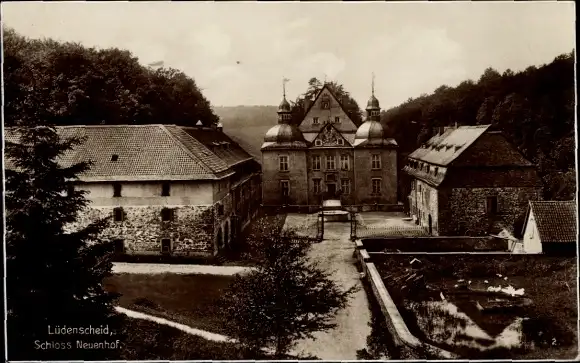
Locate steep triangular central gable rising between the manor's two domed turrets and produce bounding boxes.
[299,85,357,133]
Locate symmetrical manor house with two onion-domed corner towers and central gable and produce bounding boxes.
[261,84,397,207]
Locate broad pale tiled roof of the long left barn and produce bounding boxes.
[5,125,247,182]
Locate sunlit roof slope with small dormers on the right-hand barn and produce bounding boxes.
[409,125,491,166]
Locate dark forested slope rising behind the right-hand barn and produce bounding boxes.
[381,52,576,200]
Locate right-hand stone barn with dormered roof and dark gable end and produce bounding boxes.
[404,125,542,236]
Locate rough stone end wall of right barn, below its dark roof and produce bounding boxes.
[439,187,541,235]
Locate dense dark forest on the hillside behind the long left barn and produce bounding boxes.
[3,29,218,126]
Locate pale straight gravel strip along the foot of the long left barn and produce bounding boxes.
[113,262,251,276]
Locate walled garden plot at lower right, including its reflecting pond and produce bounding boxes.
[373,254,577,359]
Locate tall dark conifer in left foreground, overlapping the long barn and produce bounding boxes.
[5,124,123,360]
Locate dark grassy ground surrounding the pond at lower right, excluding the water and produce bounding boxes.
[375,255,578,359]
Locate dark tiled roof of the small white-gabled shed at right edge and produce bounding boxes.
[523,200,578,243]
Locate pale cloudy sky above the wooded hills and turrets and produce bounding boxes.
[2,1,575,109]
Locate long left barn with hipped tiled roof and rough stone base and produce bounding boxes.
[6,125,261,258]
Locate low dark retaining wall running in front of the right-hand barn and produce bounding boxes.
[361,237,509,252]
